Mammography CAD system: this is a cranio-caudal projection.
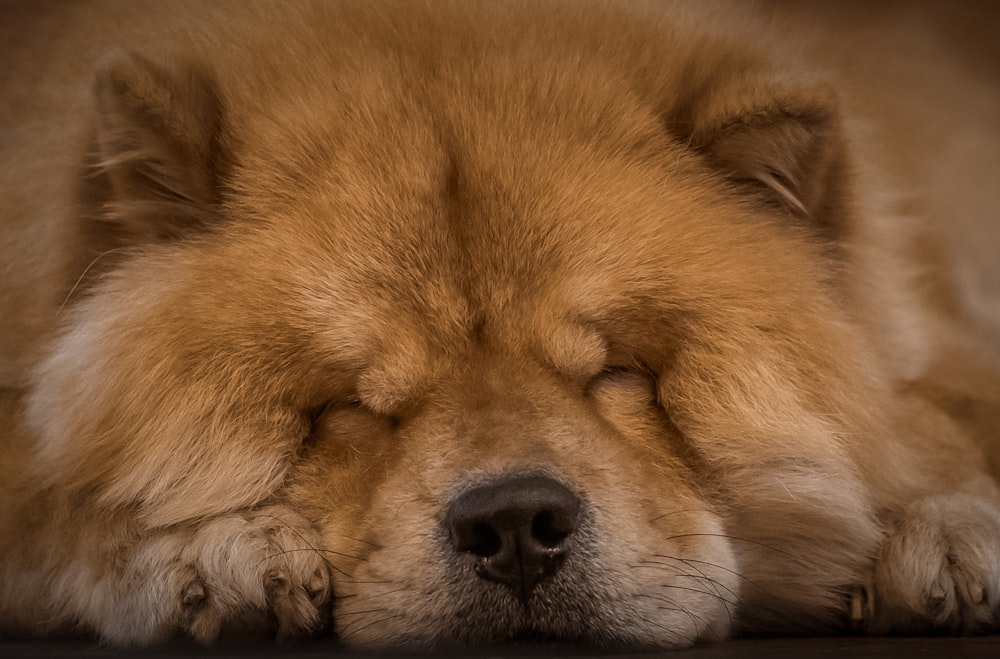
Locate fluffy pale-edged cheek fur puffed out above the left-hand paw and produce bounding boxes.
[27,254,320,527]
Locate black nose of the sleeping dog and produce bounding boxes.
[446,476,580,605]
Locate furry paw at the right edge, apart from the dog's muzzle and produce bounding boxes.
[869,494,1000,633]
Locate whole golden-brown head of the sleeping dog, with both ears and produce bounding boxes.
[23,7,888,647]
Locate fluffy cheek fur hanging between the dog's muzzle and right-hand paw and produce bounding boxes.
[658,344,879,631]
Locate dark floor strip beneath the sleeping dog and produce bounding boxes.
[0,635,1000,659]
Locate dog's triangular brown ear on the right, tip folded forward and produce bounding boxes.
[675,77,846,233]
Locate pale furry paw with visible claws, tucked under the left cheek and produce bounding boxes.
[95,506,331,645]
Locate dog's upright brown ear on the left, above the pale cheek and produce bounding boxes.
[82,53,223,248]
